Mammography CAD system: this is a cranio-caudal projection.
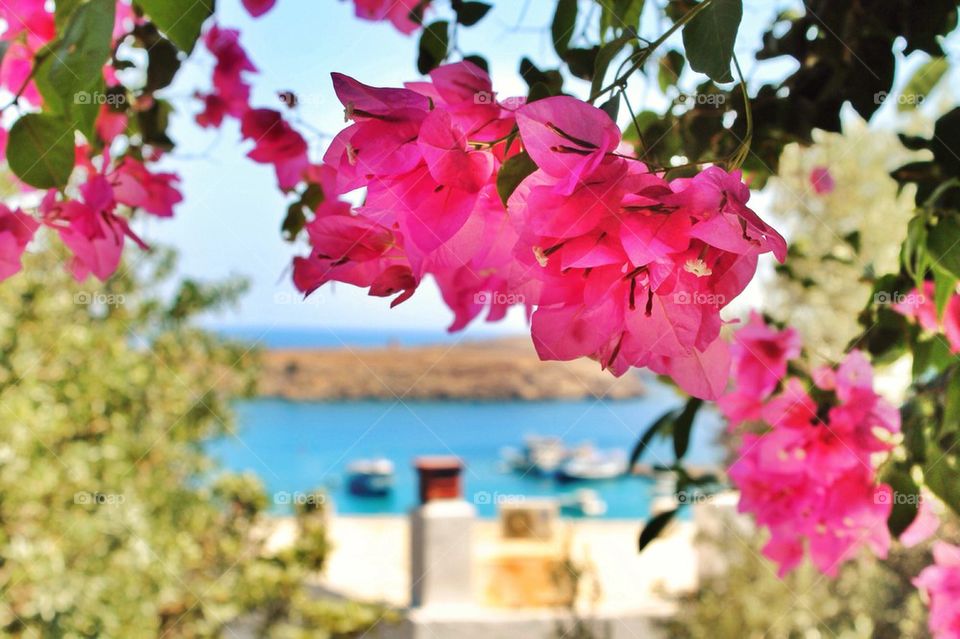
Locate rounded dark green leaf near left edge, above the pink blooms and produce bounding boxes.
[7,113,74,189]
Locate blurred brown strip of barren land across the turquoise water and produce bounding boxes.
[259,339,644,400]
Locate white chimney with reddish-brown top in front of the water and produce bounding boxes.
[410,457,476,608]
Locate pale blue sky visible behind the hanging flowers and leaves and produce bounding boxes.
[142,0,908,332]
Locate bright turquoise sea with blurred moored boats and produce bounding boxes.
[210,328,723,519]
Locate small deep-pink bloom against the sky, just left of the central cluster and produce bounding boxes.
[240,109,310,190]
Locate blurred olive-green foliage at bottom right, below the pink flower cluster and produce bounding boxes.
[666,520,960,639]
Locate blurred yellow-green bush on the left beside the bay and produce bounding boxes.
[0,248,381,638]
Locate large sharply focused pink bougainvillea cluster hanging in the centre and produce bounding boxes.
[294,62,786,398]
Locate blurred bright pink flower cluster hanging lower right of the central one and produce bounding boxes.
[719,315,900,576]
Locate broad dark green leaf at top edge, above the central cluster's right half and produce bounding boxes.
[683,0,743,82]
